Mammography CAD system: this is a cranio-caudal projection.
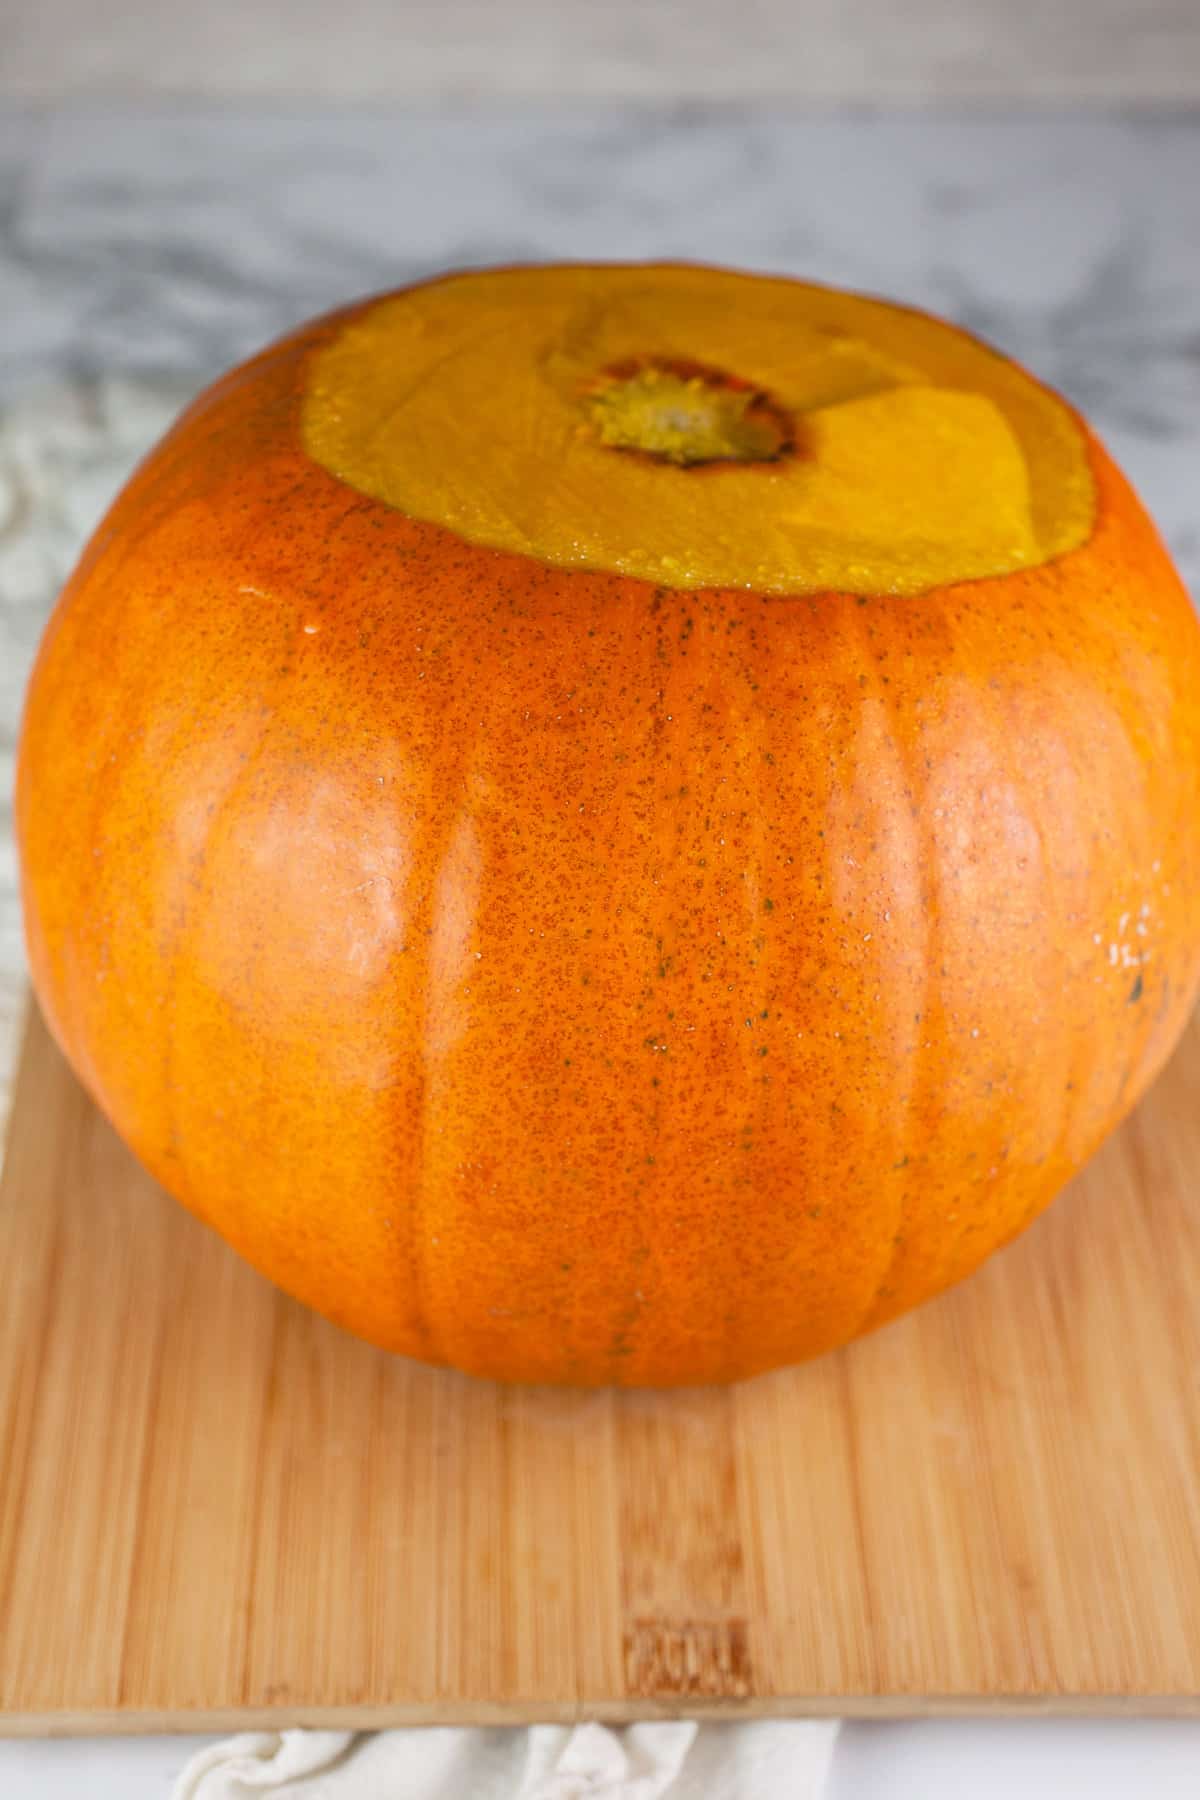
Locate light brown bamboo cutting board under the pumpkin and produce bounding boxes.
[0,1021,1200,1732]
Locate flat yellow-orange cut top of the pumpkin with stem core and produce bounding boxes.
[302,265,1096,594]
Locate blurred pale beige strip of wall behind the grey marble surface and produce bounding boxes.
[0,0,1200,104]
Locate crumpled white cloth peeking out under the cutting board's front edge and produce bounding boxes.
[173,1719,838,1800]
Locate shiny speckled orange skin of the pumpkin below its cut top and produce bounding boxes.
[18,261,1200,1384]
